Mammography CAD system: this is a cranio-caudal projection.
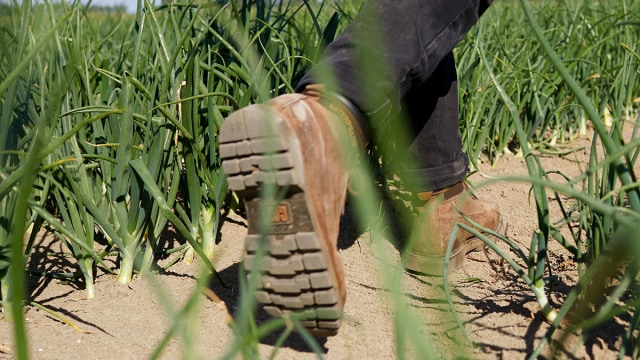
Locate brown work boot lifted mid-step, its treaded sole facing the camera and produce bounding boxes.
[220,86,359,336]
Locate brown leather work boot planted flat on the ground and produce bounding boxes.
[405,182,503,275]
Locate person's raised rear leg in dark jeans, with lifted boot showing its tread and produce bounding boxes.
[220,0,500,336]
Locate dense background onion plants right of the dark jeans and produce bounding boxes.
[456,0,640,161]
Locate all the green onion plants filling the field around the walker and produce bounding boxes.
[0,0,640,358]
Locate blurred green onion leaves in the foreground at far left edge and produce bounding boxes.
[0,4,75,359]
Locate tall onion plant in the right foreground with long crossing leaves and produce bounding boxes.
[461,0,640,358]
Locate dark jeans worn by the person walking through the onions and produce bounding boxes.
[298,0,493,191]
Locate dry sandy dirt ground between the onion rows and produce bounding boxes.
[0,127,636,360]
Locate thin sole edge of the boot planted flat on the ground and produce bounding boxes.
[405,217,504,276]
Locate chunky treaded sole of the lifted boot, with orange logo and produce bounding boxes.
[220,105,343,336]
